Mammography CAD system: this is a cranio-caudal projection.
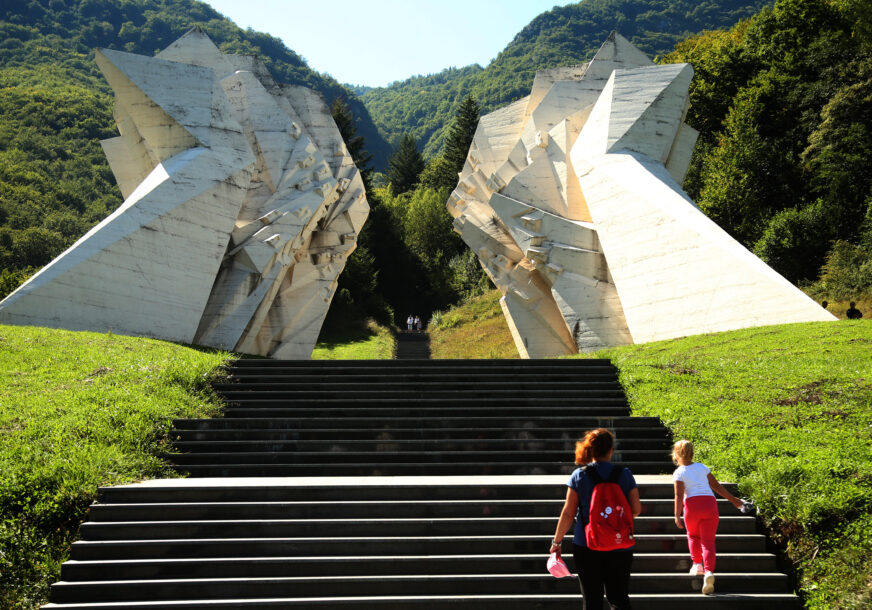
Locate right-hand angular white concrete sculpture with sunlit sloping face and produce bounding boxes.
[448,33,835,358]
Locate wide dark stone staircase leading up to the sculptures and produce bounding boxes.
[45,360,799,610]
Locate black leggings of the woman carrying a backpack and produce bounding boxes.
[572,544,633,610]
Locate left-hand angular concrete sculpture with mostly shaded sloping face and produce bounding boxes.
[0,28,369,358]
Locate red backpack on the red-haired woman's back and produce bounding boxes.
[584,465,636,551]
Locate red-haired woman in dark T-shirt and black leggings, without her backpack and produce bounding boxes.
[549,428,642,610]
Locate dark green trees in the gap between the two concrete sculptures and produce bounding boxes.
[325,96,491,335]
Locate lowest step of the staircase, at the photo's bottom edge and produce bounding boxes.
[43,592,800,610]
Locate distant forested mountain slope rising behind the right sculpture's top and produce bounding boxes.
[362,0,771,157]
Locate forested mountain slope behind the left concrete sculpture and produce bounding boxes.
[0,0,389,280]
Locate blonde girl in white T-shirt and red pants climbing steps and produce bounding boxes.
[672,440,743,595]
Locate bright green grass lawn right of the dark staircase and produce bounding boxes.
[580,320,872,610]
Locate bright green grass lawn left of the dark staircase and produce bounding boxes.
[0,326,230,609]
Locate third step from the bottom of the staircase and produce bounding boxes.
[61,553,776,581]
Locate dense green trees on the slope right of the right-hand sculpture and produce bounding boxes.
[664,0,872,288]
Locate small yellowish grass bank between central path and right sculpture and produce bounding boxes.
[427,290,518,359]
